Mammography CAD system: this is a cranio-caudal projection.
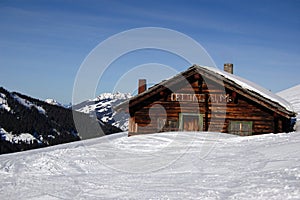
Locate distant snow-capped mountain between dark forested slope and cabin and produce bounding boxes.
[73,92,132,131]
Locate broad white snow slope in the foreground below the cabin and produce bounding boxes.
[0,132,300,200]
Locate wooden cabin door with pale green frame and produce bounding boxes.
[179,113,203,131]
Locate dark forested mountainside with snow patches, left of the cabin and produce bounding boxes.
[0,87,121,154]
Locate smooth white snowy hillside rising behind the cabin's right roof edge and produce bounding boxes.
[277,84,300,119]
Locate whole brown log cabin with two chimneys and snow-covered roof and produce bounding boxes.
[116,64,296,135]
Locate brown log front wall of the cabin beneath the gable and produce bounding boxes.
[129,74,286,135]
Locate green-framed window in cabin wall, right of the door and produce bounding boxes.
[228,121,253,135]
